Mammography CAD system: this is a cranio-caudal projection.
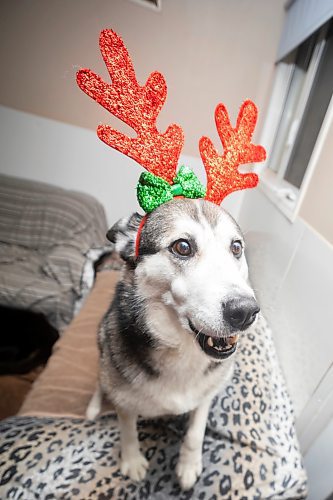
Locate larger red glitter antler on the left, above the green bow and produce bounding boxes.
[77,30,184,183]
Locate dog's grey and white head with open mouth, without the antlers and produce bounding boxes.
[107,199,259,360]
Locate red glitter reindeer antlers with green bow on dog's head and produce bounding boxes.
[77,30,266,213]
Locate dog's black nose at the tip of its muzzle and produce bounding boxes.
[223,297,260,330]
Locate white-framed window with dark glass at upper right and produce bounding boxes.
[262,23,333,219]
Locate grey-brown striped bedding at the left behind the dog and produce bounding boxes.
[0,175,107,331]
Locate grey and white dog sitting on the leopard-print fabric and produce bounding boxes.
[87,198,259,490]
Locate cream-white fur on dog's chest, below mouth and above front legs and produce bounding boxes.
[112,339,233,418]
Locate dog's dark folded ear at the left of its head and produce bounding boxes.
[106,213,143,263]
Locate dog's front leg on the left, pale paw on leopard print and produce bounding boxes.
[117,409,148,481]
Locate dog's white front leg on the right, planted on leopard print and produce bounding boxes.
[177,399,211,490]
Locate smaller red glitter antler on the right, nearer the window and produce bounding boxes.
[199,100,266,205]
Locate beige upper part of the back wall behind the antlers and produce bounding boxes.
[0,0,285,156]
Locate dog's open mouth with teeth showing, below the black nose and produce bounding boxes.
[189,321,239,359]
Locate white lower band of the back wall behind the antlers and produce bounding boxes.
[0,106,243,224]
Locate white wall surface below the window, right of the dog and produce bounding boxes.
[239,189,333,500]
